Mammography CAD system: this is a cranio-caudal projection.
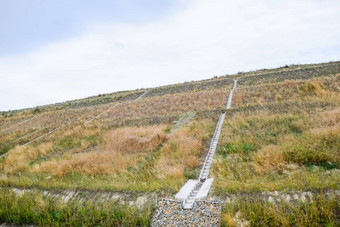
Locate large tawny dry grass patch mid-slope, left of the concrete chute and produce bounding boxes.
[31,125,166,177]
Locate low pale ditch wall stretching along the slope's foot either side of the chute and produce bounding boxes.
[5,187,340,208]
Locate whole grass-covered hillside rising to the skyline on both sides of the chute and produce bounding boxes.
[0,62,340,225]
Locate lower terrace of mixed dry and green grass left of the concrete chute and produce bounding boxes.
[0,120,213,192]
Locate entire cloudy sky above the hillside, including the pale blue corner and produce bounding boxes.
[0,0,340,110]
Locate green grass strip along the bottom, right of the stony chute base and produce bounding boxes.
[222,195,340,226]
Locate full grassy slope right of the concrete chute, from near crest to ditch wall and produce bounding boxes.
[213,74,340,193]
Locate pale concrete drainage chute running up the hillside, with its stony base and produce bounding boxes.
[151,80,237,226]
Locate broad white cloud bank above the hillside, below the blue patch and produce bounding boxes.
[0,0,340,110]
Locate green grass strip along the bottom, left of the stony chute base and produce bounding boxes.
[0,190,152,226]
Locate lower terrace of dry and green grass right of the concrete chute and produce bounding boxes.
[212,98,340,191]
